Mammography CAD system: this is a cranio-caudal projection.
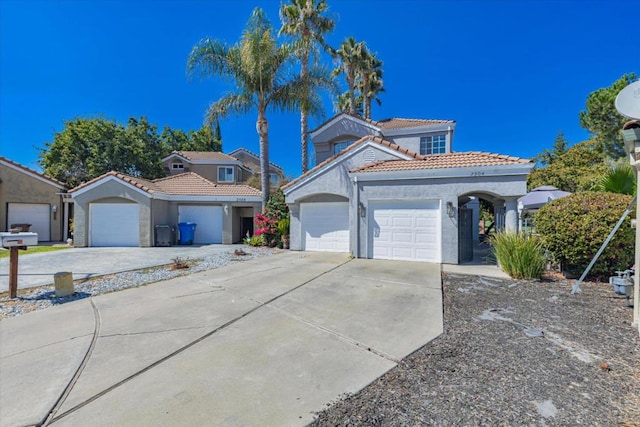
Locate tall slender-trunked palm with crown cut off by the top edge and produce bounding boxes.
[280,0,335,173]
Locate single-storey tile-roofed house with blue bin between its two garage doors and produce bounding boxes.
[70,172,261,246]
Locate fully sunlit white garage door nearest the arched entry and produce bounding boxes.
[369,200,441,262]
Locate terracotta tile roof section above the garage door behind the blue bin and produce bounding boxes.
[153,172,261,196]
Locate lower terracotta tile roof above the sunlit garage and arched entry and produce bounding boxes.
[349,151,532,172]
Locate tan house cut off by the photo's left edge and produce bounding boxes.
[0,157,71,242]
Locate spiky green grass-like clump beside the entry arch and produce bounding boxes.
[489,233,547,279]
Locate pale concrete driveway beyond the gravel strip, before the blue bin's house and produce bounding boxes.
[0,245,238,292]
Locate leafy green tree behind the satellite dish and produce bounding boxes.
[580,73,636,159]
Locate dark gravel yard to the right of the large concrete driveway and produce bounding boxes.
[312,274,640,426]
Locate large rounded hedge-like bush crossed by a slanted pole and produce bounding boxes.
[535,192,635,275]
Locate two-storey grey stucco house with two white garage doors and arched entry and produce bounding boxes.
[283,113,533,264]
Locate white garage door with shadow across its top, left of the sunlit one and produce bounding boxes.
[300,202,349,252]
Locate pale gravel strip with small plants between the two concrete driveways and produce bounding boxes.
[0,247,277,319]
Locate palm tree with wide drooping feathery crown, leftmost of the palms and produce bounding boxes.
[187,8,326,210]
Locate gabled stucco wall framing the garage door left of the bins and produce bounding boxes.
[73,181,153,247]
